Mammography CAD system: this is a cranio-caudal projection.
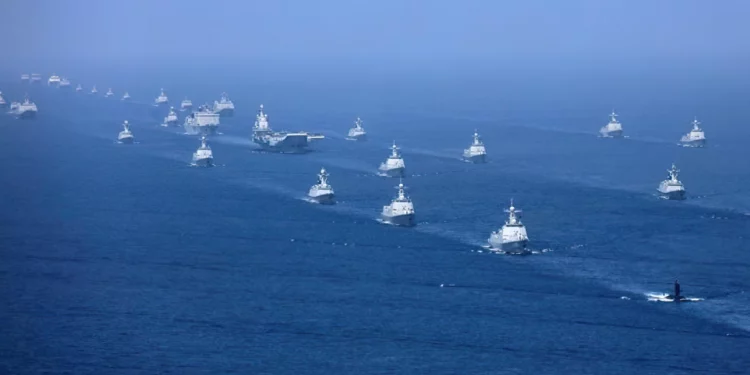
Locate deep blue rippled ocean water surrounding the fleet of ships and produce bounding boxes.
[0,73,750,374]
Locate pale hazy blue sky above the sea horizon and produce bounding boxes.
[0,0,750,70]
